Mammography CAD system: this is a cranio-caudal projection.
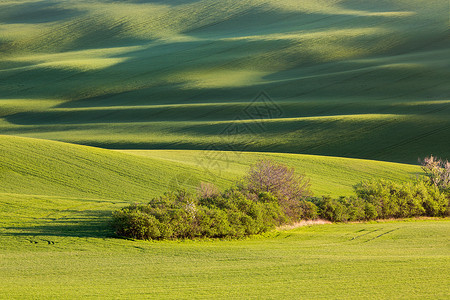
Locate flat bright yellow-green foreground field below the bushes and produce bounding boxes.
[0,220,450,299]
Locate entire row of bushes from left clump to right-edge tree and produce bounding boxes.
[113,158,450,240]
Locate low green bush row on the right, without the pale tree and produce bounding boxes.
[311,178,450,222]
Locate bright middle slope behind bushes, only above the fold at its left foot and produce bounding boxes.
[0,136,420,202]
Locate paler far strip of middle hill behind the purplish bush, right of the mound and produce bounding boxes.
[120,150,421,195]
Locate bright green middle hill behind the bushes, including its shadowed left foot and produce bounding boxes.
[0,135,426,244]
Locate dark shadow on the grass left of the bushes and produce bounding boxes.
[3,211,115,238]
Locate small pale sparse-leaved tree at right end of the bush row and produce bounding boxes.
[421,155,450,190]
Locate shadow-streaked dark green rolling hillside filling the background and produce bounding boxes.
[0,0,450,163]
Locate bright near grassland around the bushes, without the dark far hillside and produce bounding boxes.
[0,136,450,299]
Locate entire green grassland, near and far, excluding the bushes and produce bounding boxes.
[0,0,450,299]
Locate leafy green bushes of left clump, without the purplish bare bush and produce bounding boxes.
[114,189,284,240]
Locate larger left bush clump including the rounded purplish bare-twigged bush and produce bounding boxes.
[113,161,315,240]
